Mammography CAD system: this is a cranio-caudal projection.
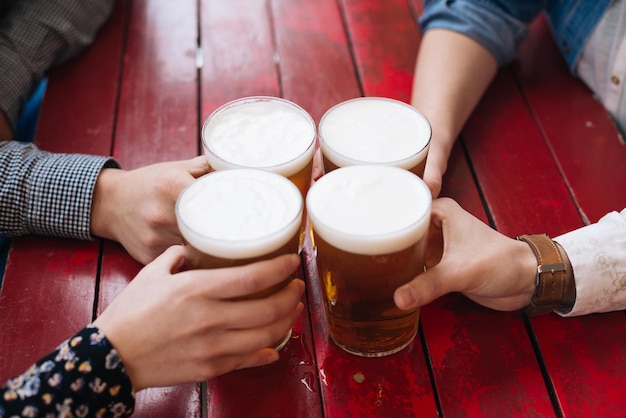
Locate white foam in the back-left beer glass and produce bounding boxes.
[202,96,316,177]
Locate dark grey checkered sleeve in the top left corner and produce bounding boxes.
[0,0,114,127]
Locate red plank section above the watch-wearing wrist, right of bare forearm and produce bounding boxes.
[462,69,580,236]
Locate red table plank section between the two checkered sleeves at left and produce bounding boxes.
[35,0,128,155]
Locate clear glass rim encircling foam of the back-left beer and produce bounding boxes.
[200,96,317,177]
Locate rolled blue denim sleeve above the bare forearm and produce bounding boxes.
[419,0,548,66]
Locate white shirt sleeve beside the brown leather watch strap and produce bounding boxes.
[554,209,626,316]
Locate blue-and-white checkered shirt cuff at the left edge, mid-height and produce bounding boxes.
[0,141,119,240]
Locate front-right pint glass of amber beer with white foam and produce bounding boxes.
[306,165,432,357]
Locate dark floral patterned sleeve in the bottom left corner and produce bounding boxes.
[0,325,135,418]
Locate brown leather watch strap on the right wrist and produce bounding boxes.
[517,234,576,316]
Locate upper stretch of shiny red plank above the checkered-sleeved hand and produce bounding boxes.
[113,0,198,168]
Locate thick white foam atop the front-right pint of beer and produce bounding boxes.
[306,165,432,255]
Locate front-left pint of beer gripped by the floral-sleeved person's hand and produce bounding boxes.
[176,169,304,350]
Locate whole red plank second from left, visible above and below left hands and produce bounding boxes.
[98,0,202,417]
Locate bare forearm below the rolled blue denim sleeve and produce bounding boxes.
[411,29,498,172]
